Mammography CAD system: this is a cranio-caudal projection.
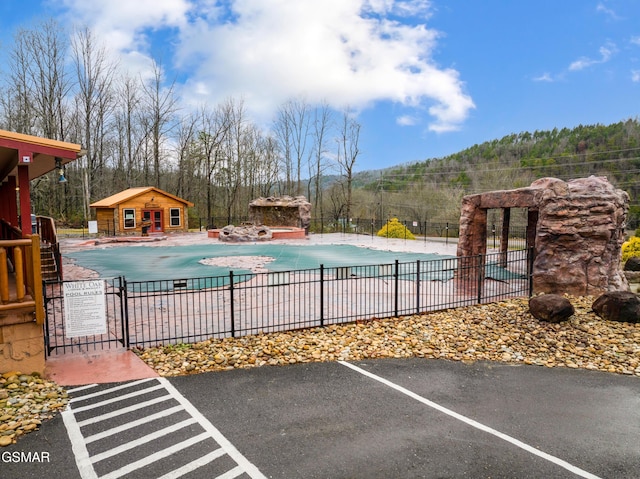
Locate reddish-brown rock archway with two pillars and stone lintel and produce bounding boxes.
[456,176,629,296]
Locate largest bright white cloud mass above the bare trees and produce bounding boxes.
[57,0,474,132]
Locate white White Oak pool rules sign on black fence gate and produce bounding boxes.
[62,279,107,338]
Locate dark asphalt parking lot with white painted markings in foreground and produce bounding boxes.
[5,359,640,479]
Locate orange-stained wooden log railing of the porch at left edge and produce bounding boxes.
[0,234,44,324]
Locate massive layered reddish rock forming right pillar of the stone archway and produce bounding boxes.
[532,176,629,296]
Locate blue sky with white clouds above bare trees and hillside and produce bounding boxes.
[0,0,640,170]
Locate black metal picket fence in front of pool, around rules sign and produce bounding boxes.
[46,250,531,354]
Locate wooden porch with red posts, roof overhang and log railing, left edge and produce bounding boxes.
[0,130,84,373]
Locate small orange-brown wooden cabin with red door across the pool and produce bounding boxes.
[90,186,193,235]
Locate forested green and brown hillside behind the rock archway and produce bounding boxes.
[354,119,640,228]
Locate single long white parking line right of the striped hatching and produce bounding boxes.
[338,361,600,479]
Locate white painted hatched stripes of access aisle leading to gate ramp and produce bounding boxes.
[62,378,266,479]
